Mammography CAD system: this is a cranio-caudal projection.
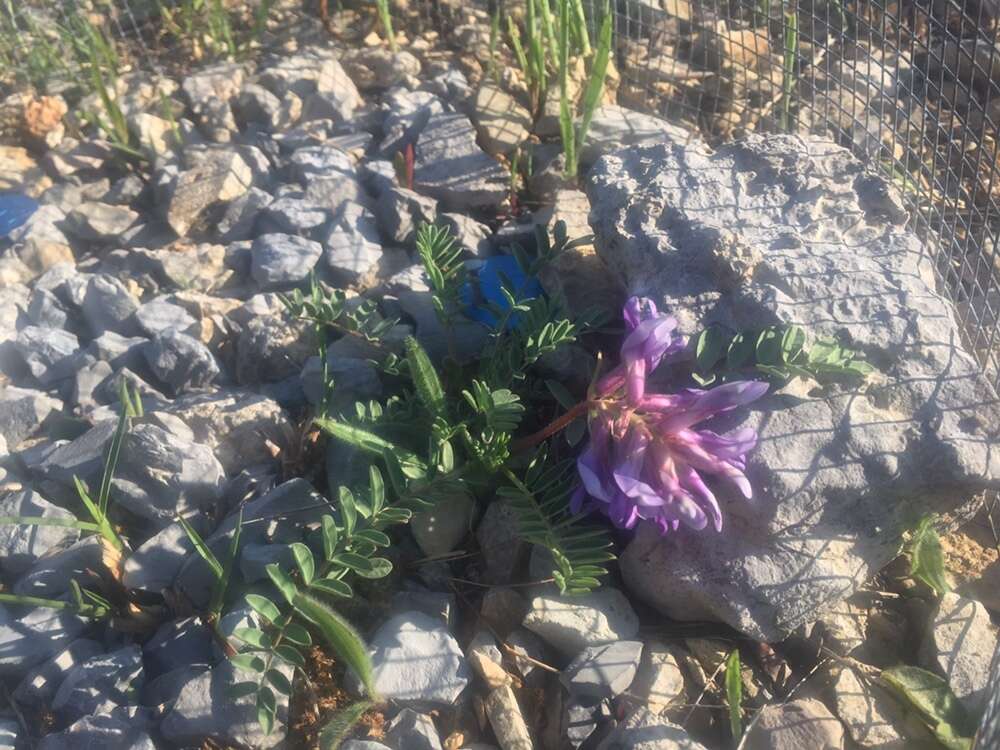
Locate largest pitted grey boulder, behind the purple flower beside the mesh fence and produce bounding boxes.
[588,136,1000,642]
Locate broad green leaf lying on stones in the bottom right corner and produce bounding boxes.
[879,665,975,750]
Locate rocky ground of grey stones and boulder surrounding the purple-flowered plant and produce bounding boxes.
[0,1,1000,750]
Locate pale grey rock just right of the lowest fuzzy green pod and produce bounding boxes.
[369,612,472,706]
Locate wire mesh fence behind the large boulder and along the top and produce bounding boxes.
[0,0,1000,736]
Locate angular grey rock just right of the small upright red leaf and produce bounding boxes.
[413,113,510,211]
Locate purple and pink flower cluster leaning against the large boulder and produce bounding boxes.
[572,297,767,533]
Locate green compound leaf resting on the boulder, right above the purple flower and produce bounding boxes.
[691,325,875,385]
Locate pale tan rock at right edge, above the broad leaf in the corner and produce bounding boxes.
[920,592,997,717]
